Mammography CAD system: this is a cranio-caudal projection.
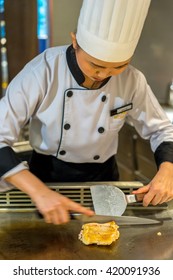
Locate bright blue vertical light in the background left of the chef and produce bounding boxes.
[37,0,49,52]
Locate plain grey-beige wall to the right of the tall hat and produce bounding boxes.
[132,0,173,104]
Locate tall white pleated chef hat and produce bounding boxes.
[76,0,151,62]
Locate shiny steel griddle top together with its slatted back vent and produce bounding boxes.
[0,182,173,260]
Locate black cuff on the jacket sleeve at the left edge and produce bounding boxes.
[0,146,21,177]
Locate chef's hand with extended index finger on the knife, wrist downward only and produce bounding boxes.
[35,189,94,225]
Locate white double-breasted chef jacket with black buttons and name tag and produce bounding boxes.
[0,43,173,178]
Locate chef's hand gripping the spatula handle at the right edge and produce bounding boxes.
[133,162,173,206]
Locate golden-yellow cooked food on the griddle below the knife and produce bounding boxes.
[79,221,120,245]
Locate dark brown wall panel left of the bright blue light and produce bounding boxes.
[4,0,38,81]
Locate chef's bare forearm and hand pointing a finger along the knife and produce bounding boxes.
[6,170,94,224]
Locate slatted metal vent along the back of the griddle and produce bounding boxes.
[0,182,167,212]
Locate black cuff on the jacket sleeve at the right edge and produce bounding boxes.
[154,142,173,168]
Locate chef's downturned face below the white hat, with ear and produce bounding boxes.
[72,34,131,81]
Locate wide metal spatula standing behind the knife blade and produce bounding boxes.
[90,185,144,216]
